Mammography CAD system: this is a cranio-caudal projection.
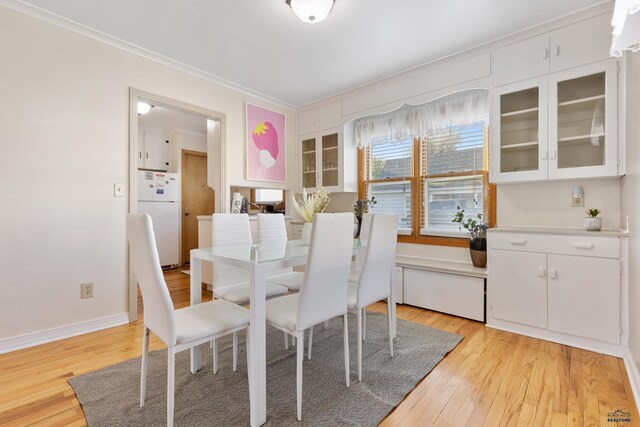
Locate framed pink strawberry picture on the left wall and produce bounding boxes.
[247,104,286,182]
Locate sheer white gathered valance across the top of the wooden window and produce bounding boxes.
[355,89,484,148]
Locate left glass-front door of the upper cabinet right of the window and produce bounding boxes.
[490,79,547,182]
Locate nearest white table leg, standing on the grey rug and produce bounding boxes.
[249,265,267,427]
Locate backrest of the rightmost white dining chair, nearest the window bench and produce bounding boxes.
[357,214,398,308]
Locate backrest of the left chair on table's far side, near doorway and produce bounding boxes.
[211,213,252,288]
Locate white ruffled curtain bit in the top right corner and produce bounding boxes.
[611,0,640,57]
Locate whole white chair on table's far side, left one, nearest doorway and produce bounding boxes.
[211,213,287,373]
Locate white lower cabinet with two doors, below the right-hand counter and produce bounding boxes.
[487,231,625,352]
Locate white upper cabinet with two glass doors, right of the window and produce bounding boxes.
[489,59,619,183]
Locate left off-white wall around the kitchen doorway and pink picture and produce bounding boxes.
[0,7,296,351]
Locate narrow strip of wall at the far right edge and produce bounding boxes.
[621,52,640,374]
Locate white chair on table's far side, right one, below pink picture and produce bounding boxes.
[258,214,304,292]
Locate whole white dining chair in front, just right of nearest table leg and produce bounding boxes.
[266,213,353,421]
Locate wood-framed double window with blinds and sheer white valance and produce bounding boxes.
[355,91,494,245]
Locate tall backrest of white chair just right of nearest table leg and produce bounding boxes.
[296,213,353,331]
